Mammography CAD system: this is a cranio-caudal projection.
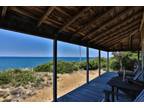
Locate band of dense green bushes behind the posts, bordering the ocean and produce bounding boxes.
[34,58,106,74]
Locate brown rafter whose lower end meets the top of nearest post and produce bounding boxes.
[58,7,90,32]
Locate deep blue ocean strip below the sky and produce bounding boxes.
[0,57,92,71]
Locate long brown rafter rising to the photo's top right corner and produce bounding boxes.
[82,7,140,40]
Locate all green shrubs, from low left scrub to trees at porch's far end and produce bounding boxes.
[0,52,137,86]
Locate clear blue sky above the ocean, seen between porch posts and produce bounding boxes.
[0,29,111,57]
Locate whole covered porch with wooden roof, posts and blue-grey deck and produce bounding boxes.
[0,6,144,102]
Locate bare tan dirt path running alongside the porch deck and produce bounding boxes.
[24,71,98,102]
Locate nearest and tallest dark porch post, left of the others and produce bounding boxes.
[53,39,57,102]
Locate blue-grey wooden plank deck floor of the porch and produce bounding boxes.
[58,72,130,102]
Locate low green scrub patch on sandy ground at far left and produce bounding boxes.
[0,69,42,86]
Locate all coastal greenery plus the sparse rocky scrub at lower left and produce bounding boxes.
[0,52,137,101]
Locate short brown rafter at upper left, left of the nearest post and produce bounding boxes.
[37,6,55,27]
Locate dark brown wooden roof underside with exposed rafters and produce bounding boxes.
[0,6,143,51]
